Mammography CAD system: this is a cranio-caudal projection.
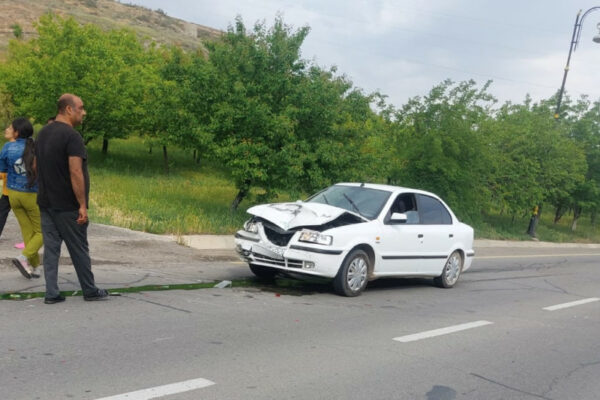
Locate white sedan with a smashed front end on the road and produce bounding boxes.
[235,183,475,296]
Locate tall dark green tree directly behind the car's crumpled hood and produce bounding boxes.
[209,17,308,209]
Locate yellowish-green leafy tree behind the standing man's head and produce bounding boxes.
[2,14,146,153]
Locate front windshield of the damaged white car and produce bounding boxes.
[306,185,391,219]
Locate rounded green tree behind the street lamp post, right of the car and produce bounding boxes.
[490,98,587,235]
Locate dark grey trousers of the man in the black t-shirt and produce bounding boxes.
[40,208,98,298]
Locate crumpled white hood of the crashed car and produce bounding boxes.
[248,202,364,231]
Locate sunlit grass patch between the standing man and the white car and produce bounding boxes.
[88,139,270,234]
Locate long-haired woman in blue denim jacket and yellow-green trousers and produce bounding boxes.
[0,118,43,279]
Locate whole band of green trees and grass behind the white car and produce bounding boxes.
[0,15,600,241]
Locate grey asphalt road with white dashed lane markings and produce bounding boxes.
[0,250,600,400]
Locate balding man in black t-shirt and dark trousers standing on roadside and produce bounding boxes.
[35,94,108,304]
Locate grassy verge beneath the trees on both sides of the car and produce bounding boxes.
[88,138,600,243]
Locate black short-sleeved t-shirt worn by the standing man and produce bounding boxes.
[35,121,90,211]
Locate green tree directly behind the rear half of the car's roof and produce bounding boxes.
[390,80,495,220]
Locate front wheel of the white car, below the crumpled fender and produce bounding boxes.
[333,249,371,297]
